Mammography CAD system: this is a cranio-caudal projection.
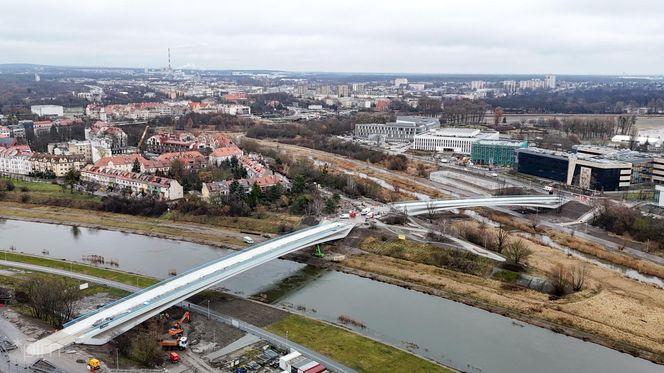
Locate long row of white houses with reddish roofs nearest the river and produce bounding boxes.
[81,166,184,200]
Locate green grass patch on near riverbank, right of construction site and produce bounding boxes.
[266,315,452,373]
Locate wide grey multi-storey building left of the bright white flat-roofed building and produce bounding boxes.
[355,117,440,142]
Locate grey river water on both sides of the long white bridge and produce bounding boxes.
[0,220,664,373]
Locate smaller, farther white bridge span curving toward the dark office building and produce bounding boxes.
[390,195,564,216]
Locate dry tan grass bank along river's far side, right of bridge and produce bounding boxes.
[290,238,664,364]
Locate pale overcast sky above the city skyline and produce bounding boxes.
[0,0,664,74]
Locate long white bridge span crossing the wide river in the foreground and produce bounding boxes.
[26,222,354,355]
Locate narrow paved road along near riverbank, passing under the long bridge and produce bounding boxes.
[0,260,355,373]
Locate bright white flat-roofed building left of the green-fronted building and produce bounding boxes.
[413,128,499,154]
